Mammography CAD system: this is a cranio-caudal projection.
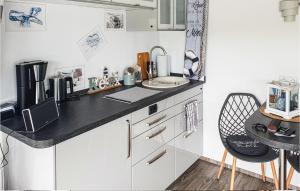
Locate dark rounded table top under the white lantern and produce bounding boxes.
[245,110,300,152]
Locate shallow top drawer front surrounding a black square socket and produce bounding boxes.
[132,97,174,124]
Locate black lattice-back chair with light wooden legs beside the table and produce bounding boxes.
[217,93,279,190]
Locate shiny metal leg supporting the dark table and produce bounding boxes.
[279,149,287,190]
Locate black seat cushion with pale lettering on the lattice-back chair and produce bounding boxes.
[226,135,269,156]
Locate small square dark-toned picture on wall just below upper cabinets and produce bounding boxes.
[104,11,126,31]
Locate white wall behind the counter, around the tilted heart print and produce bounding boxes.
[0,0,158,102]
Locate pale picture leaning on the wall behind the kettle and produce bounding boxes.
[55,66,85,91]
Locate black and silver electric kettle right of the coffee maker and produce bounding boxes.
[49,76,74,102]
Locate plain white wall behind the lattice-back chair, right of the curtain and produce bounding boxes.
[204,0,300,186]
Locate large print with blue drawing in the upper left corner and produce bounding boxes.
[4,2,46,32]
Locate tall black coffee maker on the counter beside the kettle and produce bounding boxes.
[16,60,48,113]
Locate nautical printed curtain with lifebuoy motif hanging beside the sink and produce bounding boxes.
[184,0,209,81]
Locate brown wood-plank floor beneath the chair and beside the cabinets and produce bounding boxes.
[168,160,275,190]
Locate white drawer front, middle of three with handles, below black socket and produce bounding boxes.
[132,119,174,164]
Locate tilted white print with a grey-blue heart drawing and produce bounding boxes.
[78,26,105,60]
